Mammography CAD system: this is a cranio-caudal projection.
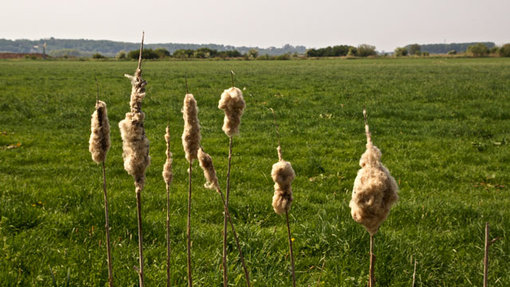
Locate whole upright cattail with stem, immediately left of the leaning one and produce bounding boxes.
[182,93,201,287]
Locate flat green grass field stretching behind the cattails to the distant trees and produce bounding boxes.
[0,58,510,287]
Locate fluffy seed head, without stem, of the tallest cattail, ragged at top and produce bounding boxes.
[119,69,150,190]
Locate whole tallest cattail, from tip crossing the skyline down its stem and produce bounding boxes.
[119,32,150,287]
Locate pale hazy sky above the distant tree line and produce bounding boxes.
[0,0,510,51]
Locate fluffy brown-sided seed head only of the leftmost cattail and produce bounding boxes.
[89,101,110,163]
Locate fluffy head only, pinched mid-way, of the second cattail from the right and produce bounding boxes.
[271,160,296,214]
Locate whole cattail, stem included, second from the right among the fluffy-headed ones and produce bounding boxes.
[271,109,296,287]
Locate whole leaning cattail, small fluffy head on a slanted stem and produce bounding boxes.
[198,148,251,287]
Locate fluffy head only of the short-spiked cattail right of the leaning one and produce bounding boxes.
[218,87,246,137]
